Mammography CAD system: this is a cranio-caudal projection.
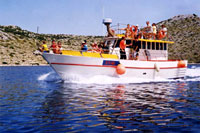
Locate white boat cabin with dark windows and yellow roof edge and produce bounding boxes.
[105,37,174,60]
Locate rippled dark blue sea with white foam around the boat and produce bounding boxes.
[0,64,200,133]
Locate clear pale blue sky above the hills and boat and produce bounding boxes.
[0,0,200,35]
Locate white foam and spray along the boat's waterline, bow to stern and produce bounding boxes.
[38,66,200,84]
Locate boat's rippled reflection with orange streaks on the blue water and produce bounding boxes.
[35,82,200,131]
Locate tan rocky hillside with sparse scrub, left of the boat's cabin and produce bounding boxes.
[0,26,102,65]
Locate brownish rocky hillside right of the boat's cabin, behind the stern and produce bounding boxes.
[157,14,200,63]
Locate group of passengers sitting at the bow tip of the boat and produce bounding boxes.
[39,40,62,54]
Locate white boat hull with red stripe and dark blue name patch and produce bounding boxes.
[43,53,187,80]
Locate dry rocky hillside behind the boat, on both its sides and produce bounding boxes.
[0,14,200,65]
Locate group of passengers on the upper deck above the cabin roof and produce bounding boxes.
[119,21,167,40]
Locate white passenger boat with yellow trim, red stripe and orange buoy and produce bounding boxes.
[42,20,188,80]
